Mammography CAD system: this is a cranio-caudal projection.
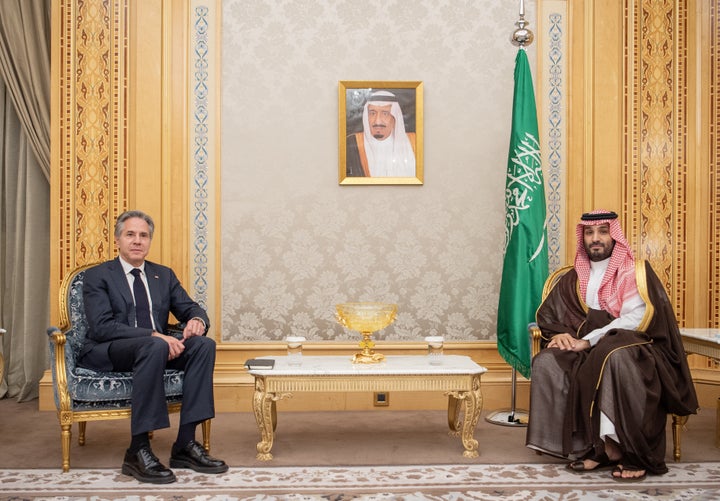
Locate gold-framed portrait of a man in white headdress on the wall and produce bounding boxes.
[338,81,423,185]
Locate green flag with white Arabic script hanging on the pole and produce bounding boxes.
[497,49,548,378]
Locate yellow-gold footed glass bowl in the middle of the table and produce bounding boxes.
[335,303,397,364]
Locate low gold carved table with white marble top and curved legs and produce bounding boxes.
[249,355,486,461]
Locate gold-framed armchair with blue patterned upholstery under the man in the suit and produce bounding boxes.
[48,265,210,472]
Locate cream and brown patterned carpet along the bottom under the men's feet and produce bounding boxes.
[0,462,720,501]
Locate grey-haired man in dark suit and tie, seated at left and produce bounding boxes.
[80,211,228,484]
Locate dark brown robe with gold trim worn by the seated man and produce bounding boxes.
[526,261,698,474]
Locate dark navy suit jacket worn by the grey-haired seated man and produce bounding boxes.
[80,258,210,370]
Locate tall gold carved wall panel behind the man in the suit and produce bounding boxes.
[51,0,128,318]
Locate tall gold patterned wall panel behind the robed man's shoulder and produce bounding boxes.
[624,0,688,318]
